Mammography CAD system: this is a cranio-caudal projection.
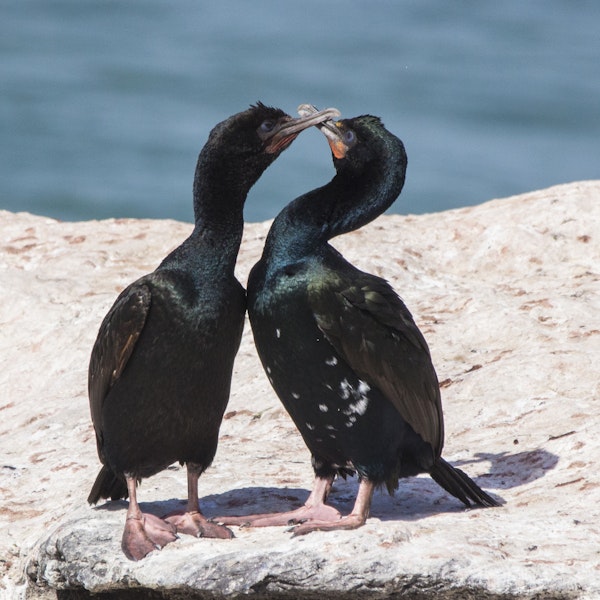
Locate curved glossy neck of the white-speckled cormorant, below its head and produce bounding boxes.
[263,158,404,269]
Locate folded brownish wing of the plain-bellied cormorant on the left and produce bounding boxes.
[88,281,151,454]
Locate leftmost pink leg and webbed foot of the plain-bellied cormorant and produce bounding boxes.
[121,477,177,560]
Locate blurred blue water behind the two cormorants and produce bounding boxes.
[0,0,600,221]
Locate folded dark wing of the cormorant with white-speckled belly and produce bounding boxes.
[309,271,444,456]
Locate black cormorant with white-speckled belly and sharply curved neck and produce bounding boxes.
[220,106,498,535]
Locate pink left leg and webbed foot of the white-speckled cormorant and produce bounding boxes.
[213,477,341,527]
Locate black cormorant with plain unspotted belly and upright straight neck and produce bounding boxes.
[88,103,339,560]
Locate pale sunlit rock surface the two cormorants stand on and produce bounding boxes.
[0,181,600,599]
